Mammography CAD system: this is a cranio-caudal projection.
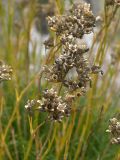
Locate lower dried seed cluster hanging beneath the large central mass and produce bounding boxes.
[25,88,73,122]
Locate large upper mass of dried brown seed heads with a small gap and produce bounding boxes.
[44,3,101,91]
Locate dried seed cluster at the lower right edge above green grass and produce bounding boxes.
[106,118,120,144]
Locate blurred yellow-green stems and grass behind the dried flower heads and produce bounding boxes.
[0,0,120,160]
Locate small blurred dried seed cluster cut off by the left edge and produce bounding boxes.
[0,62,13,83]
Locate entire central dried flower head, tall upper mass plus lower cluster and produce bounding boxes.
[25,2,102,121]
